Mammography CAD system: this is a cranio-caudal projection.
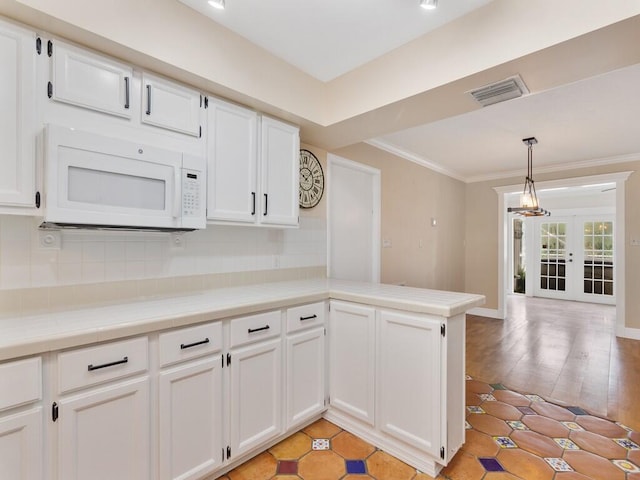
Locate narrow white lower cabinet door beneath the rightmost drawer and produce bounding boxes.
[286,328,325,429]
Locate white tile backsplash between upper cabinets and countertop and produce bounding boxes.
[0,215,327,291]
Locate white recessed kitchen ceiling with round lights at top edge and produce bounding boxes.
[179,0,492,82]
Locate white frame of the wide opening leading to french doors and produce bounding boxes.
[492,171,640,339]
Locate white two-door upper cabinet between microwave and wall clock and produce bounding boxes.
[207,99,300,226]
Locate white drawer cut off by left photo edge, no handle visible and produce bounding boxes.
[0,357,42,411]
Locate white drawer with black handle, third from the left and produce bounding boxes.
[160,322,222,367]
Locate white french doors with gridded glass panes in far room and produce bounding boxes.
[534,215,616,305]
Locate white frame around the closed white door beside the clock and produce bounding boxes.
[327,153,381,283]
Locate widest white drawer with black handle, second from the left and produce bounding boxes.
[58,337,149,393]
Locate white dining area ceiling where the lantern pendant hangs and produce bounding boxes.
[374,65,640,181]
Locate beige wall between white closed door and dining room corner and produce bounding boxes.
[332,143,465,291]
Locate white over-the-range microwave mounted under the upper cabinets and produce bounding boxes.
[41,125,206,231]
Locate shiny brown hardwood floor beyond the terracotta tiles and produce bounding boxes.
[466,295,640,430]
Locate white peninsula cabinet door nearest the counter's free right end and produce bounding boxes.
[377,311,443,458]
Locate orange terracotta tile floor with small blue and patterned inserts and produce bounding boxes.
[215,377,640,480]
